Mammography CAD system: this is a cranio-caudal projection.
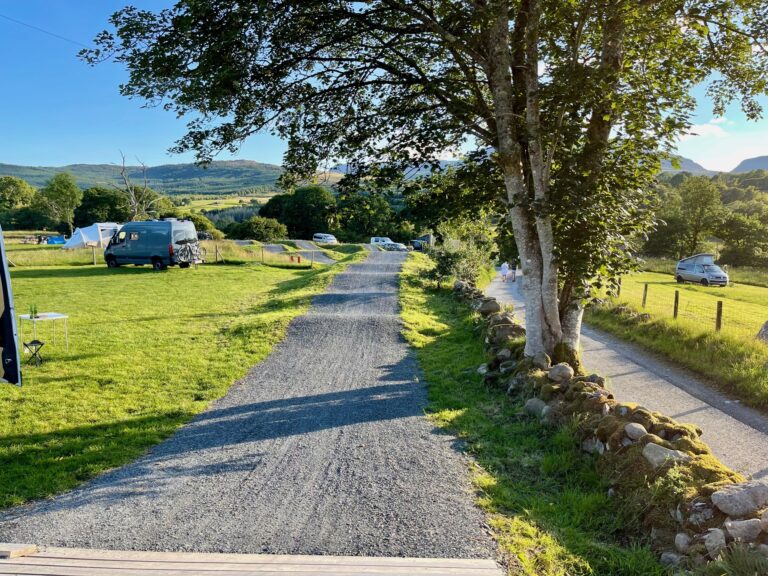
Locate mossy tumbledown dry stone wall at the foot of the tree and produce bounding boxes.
[454,281,768,571]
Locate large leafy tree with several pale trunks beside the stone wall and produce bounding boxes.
[83,0,768,357]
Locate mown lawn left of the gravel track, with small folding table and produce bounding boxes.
[0,256,354,507]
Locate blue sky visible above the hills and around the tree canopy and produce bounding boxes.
[0,0,768,170]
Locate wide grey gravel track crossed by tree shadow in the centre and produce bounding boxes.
[0,252,493,558]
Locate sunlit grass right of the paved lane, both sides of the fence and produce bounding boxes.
[585,272,768,408]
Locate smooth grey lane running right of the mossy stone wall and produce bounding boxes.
[486,276,768,478]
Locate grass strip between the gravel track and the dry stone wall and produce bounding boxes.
[400,254,663,576]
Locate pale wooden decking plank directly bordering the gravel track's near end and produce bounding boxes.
[35,547,498,572]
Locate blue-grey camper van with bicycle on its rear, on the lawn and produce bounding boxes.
[104,218,198,270]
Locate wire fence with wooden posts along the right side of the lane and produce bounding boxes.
[614,282,768,340]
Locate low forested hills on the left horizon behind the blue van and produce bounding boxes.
[0,160,283,194]
